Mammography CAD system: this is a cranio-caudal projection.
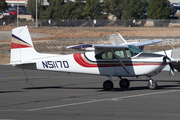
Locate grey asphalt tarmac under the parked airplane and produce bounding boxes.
[0,65,180,120]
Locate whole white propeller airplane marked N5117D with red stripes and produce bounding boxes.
[10,26,179,90]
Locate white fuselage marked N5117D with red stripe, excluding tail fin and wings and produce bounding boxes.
[35,51,166,77]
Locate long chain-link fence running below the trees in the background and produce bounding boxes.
[0,19,180,27]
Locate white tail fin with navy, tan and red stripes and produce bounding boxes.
[10,26,37,64]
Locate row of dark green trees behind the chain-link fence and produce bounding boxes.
[0,0,173,19]
